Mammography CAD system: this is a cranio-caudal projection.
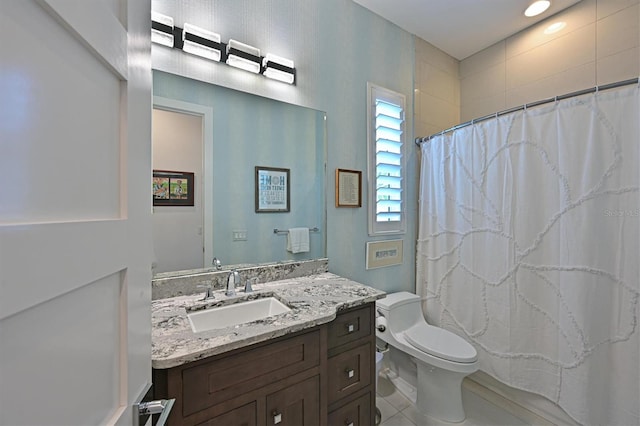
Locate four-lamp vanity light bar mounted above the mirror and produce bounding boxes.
[151,11,297,84]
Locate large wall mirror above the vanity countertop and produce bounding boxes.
[152,71,326,275]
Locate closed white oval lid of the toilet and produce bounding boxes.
[404,323,478,362]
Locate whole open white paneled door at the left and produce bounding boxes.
[0,0,151,425]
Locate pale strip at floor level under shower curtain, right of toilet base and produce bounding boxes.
[462,371,578,426]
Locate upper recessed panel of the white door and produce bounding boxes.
[0,2,124,223]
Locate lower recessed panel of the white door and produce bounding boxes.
[0,274,122,425]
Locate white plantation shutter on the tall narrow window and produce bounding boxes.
[367,83,406,235]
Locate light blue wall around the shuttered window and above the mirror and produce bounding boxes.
[152,0,418,291]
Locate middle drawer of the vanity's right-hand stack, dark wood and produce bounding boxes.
[328,343,373,404]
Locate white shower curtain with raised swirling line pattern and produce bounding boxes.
[417,85,640,425]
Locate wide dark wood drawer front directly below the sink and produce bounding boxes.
[182,331,320,416]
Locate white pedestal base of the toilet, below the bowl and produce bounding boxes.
[416,362,468,423]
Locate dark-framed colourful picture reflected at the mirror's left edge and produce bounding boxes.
[153,170,194,206]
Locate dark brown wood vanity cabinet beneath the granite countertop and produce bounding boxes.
[153,304,375,426]
